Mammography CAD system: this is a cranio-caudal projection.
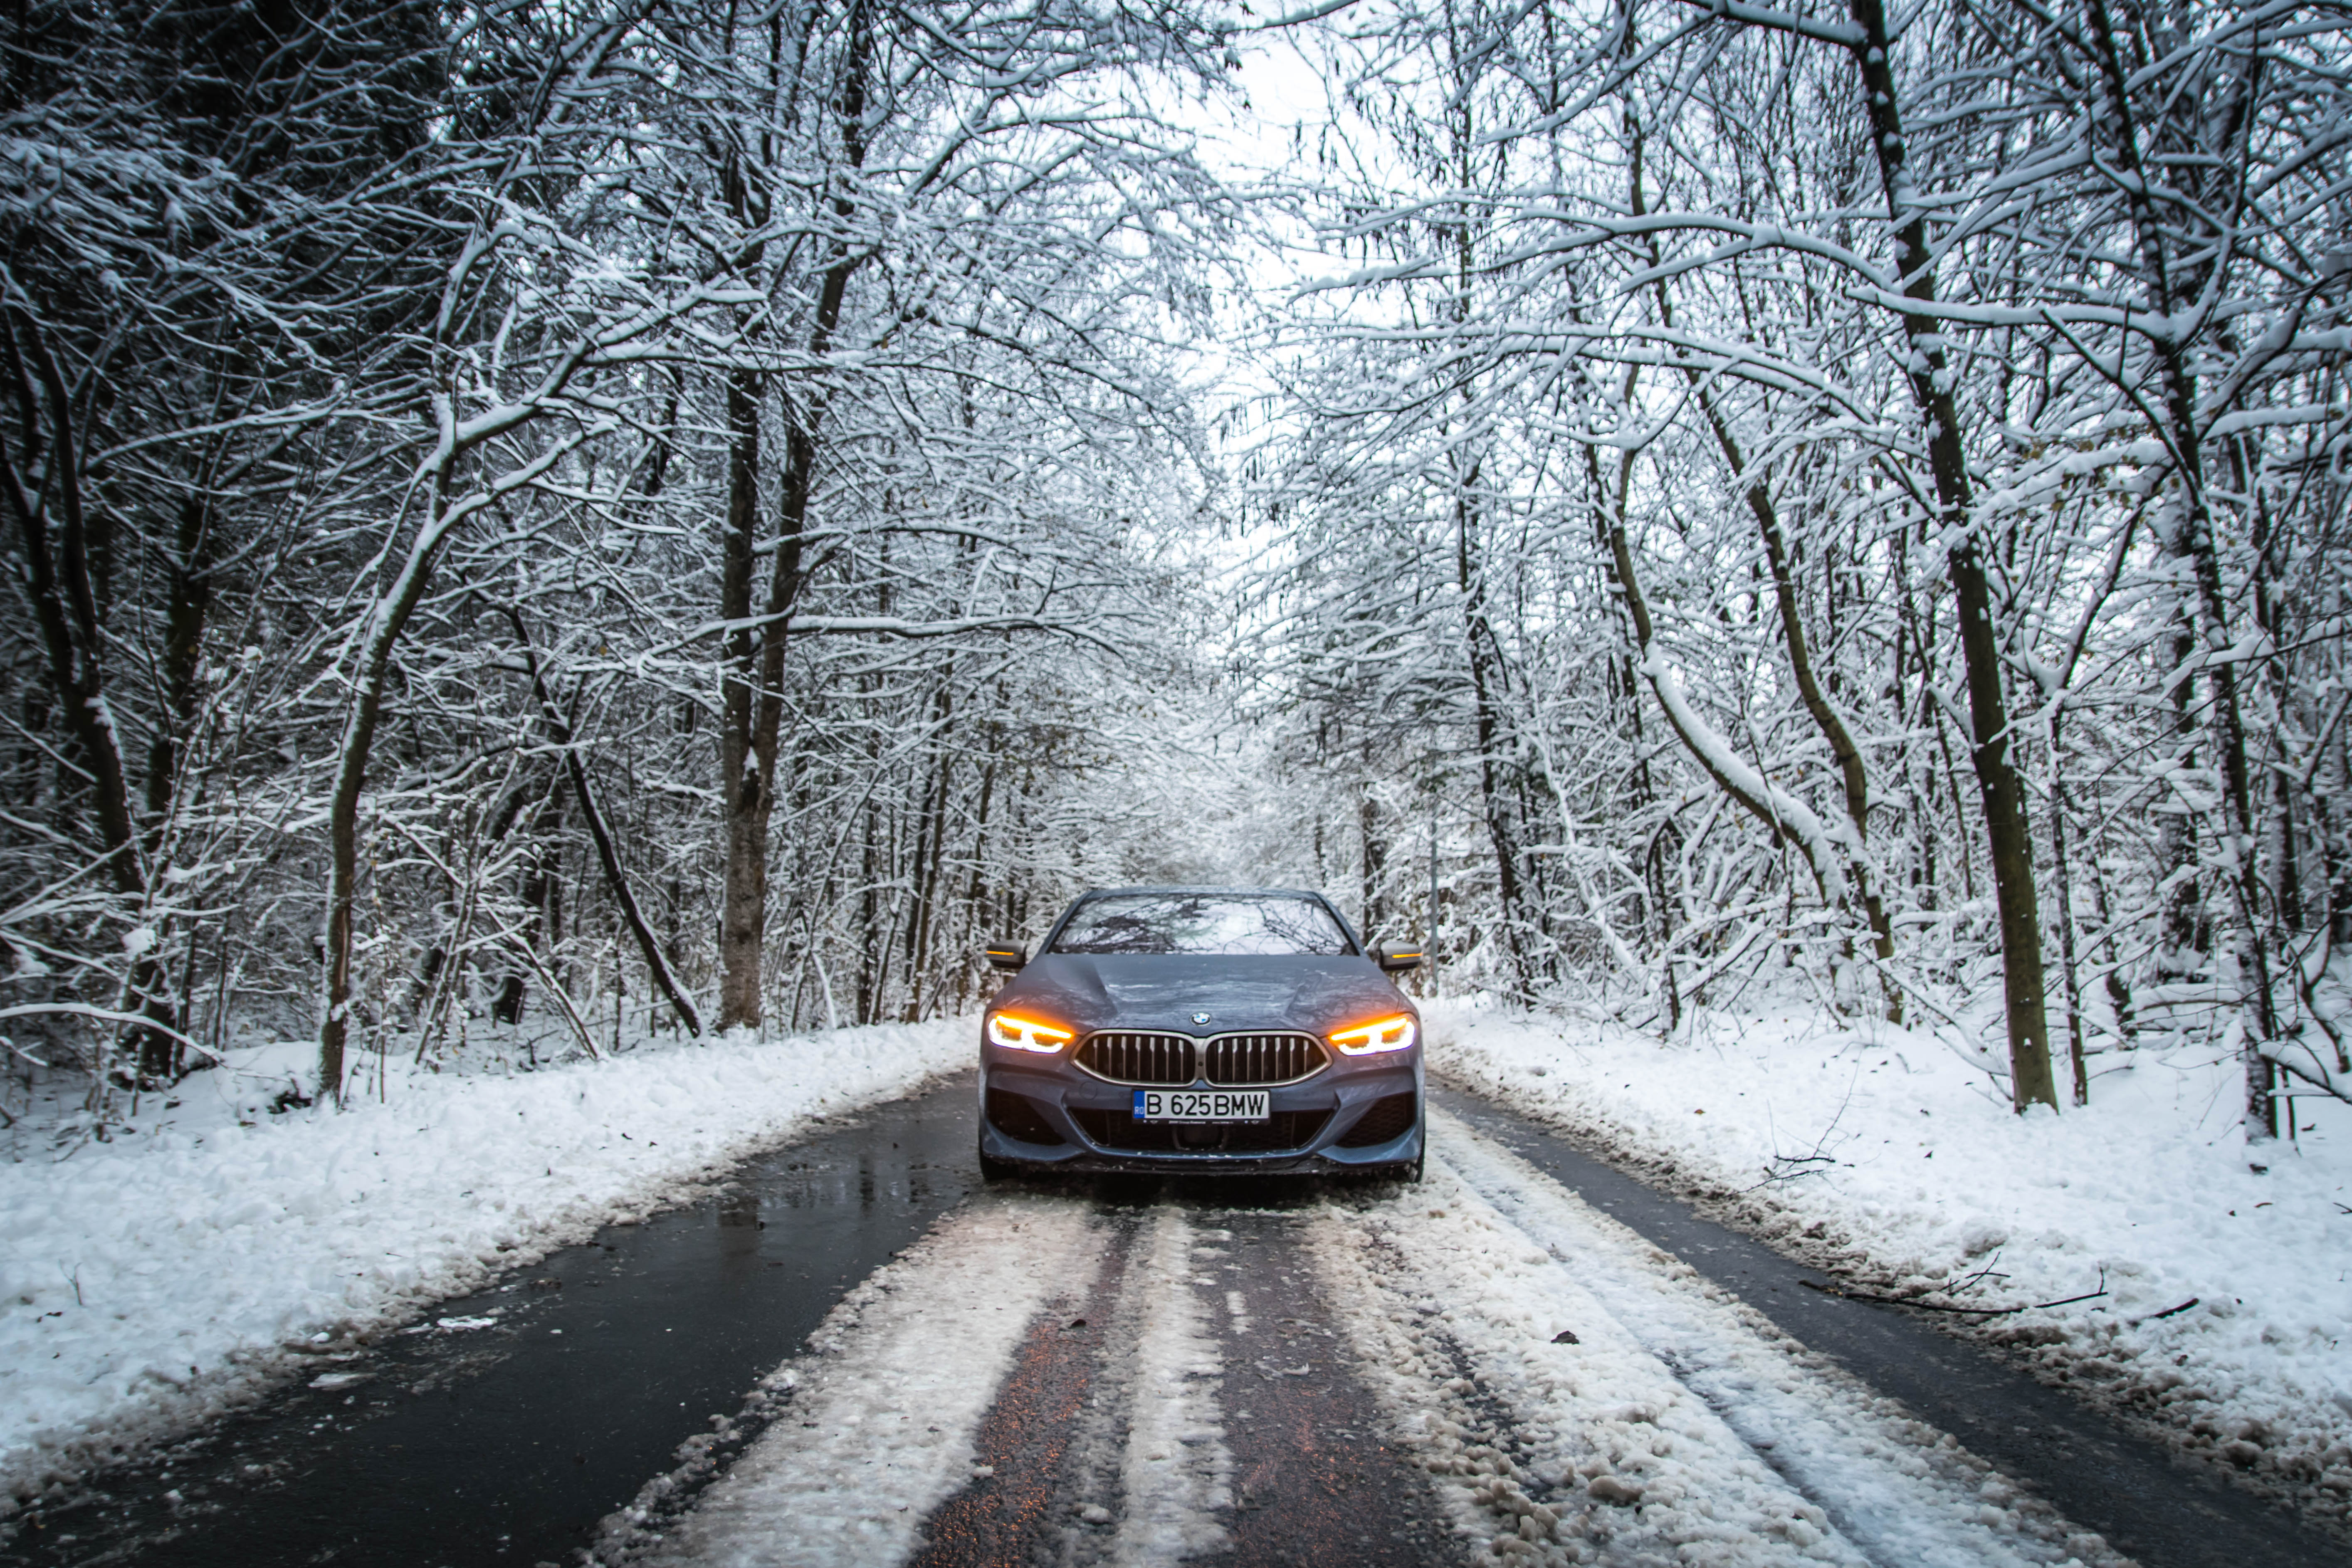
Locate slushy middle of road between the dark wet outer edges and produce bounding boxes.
[602,1112,2126,1568]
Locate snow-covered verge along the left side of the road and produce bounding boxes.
[0,1020,971,1511]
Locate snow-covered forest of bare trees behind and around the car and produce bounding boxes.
[0,0,2352,1140]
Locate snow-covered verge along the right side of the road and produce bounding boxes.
[1430,1006,2352,1521]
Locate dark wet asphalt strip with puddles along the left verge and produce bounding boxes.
[0,1077,978,1568]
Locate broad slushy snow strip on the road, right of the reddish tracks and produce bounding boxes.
[1315,1114,2119,1568]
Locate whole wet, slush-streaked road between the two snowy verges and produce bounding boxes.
[0,1079,2345,1568]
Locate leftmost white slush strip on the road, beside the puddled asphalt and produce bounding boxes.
[625,1197,1103,1568]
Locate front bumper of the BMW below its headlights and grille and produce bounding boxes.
[981,1046,1423,1175]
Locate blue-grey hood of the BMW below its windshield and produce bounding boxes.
[993,952,1411,1035]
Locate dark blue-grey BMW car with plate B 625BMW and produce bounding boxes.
[981,889,1423,1180]
